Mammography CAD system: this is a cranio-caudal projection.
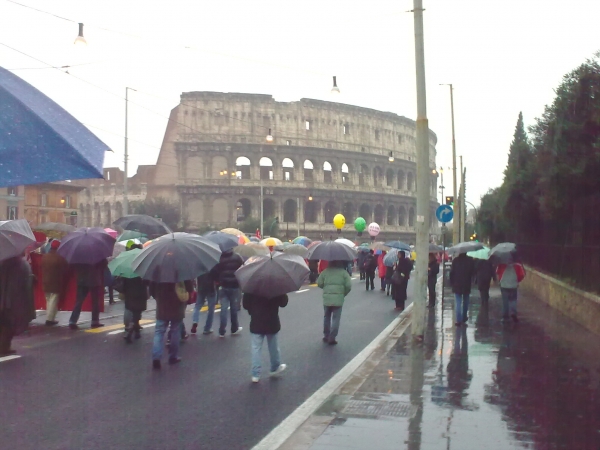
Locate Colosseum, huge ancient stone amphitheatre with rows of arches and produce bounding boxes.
[81,92,437,242]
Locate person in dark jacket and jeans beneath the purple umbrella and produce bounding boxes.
[69,259,107,330]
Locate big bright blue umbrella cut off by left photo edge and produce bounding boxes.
[0,67,109,186]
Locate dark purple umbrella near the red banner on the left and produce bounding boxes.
[57,227,116,264]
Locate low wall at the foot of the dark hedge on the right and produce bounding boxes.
[520,267,600,334]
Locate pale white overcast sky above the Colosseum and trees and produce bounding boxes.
[0,0,600,204]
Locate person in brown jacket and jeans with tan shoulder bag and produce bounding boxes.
[150,280,194,369]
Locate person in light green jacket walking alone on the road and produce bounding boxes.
[317,261,352,345]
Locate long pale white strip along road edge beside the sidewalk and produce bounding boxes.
[252,303,413,450]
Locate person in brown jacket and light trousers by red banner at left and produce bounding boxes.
[42,240,68,326]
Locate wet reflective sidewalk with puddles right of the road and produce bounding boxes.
[279,288,600,450]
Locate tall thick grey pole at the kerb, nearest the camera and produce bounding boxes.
[411,0,430,340]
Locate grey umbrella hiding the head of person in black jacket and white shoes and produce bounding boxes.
[235,252,310,298]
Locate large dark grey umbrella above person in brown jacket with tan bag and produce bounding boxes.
[131,233,221,283]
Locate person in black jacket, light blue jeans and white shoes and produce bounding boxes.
[242,293,288,383]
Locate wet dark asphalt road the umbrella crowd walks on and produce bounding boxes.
[0,280,408,450]
